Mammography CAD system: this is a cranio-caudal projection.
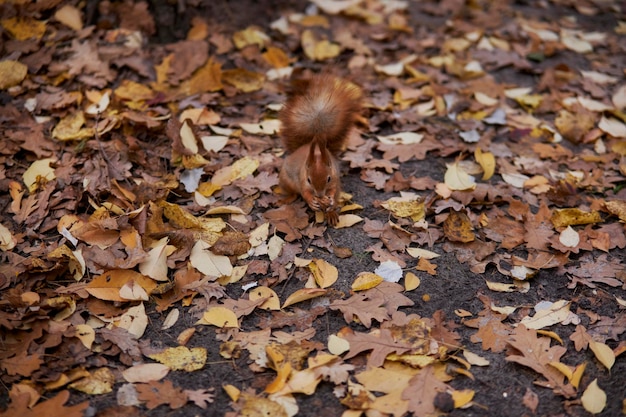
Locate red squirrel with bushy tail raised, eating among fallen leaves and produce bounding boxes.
[279,75,361,226]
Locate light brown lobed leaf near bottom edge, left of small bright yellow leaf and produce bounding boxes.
[402,365,448,416]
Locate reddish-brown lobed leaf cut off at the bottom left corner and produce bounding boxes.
[0,391,89,417]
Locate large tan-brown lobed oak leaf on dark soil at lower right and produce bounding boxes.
[506,325,576,398]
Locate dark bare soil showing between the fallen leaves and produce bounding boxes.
[0,0,626,417]
